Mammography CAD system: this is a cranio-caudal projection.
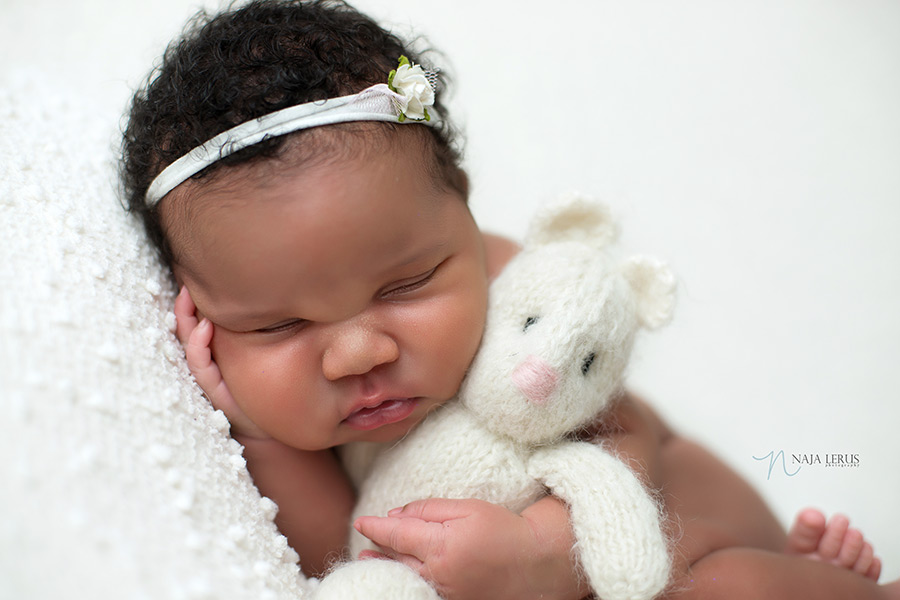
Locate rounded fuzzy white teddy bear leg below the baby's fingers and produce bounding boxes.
[311,559,440,600]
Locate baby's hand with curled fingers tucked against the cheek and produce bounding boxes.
[175,287,269,439]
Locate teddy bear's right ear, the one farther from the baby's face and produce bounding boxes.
[622,256,676,329]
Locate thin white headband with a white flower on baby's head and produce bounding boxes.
[144,56,439,206]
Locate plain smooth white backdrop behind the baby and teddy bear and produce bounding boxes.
[0,0,900,578]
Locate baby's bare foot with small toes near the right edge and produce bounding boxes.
[785,508,881,581]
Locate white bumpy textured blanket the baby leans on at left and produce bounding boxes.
[0,72,306,599]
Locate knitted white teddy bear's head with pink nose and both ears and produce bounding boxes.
[460,197,675,445]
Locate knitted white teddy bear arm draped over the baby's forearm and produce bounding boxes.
[528,442,670,600]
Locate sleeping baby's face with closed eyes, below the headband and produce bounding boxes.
[169,136,487,450]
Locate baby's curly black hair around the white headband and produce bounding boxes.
[120,0,468,266]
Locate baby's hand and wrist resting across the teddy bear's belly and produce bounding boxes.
[354,498,584,600]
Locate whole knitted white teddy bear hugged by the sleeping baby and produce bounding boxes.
[316,197,675,600]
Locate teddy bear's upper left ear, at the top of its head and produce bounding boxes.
[525,194,618,249]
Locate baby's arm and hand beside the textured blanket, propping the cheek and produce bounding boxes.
[175,288,355,575]
